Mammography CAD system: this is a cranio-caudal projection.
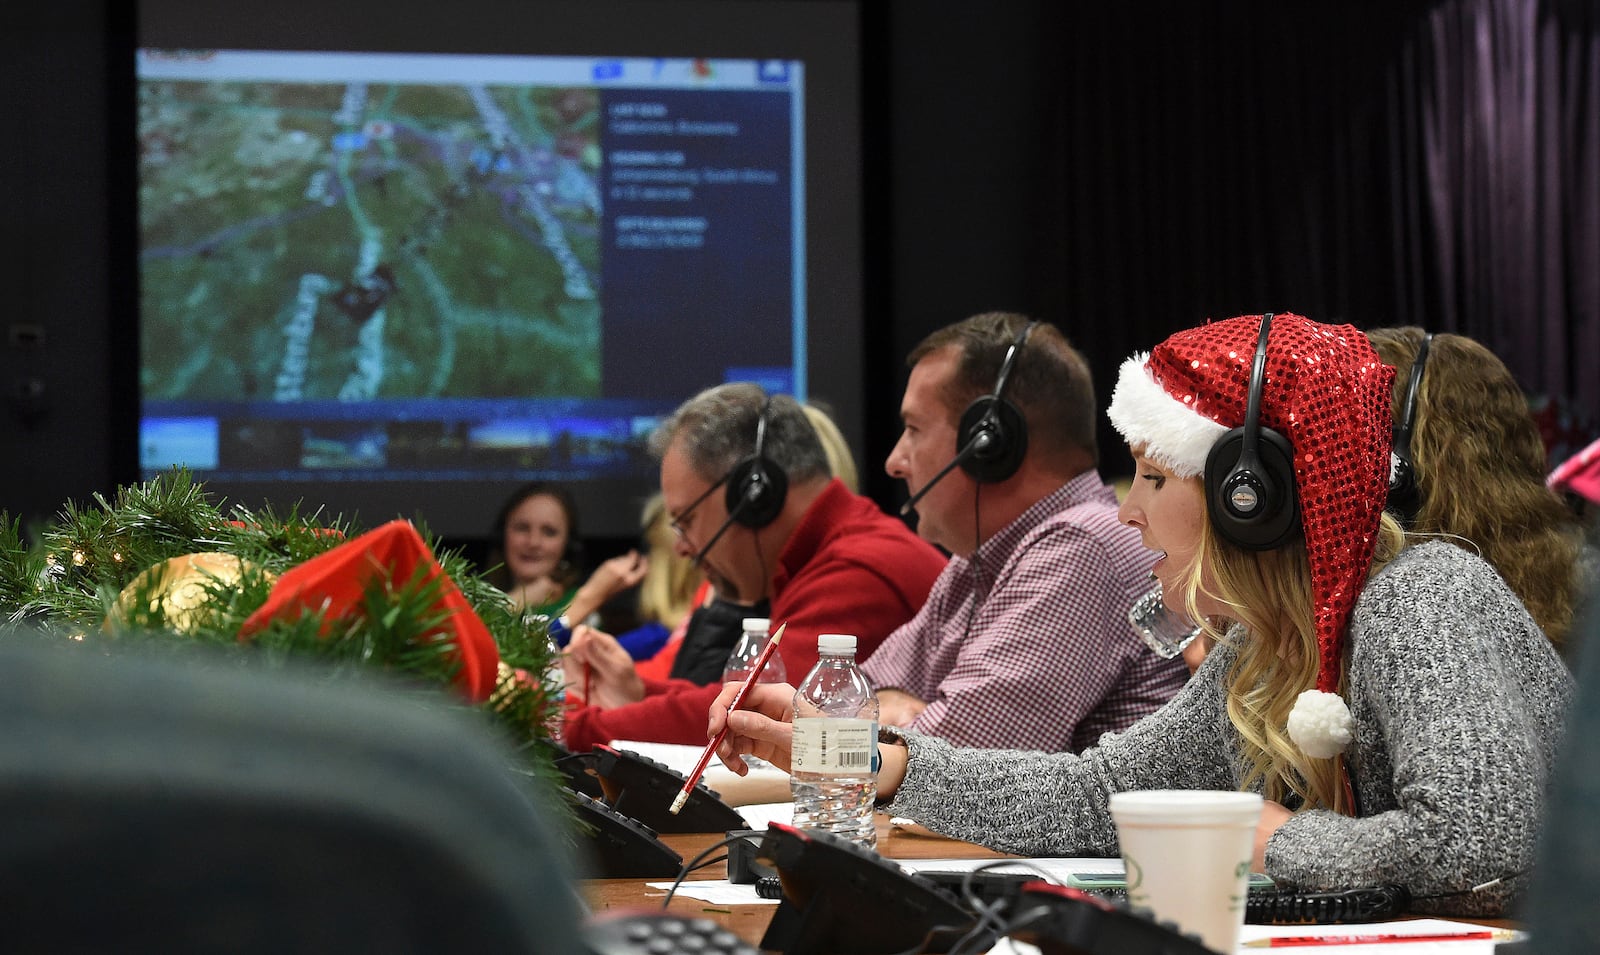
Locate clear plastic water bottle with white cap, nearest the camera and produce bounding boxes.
[789,633,878,848]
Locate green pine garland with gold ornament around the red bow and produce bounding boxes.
[0,469,560,803]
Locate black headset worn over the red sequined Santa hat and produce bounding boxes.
[1205,312,1301,550]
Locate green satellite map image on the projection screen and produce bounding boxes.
[138,80,600,402]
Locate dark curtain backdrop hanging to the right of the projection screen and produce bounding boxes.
[1018,0,1600,474]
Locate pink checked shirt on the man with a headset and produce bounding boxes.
[862,470,1189,752]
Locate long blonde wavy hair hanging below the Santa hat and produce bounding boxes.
[1178,505,1405,814]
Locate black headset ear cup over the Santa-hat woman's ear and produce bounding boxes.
[1205,427,1301,550]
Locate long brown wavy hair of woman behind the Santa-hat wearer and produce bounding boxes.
[1366,326,1582,648]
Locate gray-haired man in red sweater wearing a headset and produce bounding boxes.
[563,382,946,752]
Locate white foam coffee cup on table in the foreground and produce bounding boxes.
[1110,789,1261,955]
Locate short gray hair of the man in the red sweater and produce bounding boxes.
[650,382,832,483]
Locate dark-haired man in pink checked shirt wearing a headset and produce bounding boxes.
[862,314,1187,752]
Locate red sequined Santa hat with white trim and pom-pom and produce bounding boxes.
[1109,314,1394,758]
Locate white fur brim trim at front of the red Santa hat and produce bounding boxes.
[1106,352,1229,478]
